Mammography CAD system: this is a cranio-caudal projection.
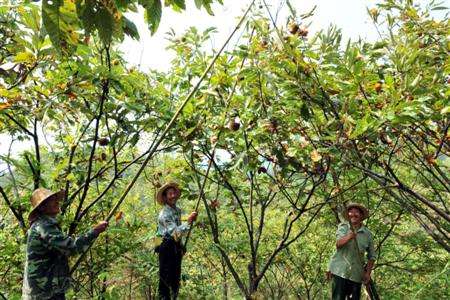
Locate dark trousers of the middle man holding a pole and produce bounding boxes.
[158,238,183,300]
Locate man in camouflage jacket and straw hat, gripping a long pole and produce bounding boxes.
[22,188,108,300]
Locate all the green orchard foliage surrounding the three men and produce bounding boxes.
[0,0,450,299]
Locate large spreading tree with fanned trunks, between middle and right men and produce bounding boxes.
[158,1,449,298]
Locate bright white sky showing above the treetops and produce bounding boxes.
[119,0,380,71]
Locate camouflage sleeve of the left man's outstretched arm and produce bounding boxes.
[41,225,97,256]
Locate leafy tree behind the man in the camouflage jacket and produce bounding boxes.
[0,1,220,297]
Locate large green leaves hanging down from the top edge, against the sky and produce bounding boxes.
[38,0,222,54]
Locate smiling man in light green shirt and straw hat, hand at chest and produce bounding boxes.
[329,203,376,300]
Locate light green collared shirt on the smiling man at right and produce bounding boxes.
[328,223,376,282]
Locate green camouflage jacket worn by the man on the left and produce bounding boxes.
[22,216,97,300]
